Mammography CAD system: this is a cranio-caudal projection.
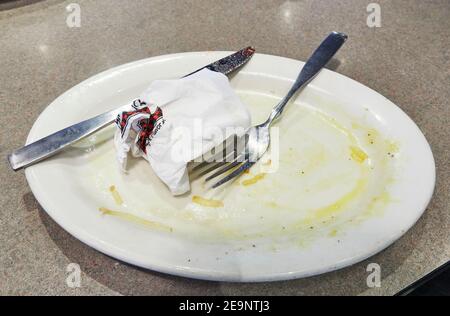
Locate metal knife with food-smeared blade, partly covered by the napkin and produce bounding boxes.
[8,47,255,170]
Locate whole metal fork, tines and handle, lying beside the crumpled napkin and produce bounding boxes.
[198,32,347,188]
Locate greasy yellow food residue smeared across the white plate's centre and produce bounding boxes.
[84,92,403,249]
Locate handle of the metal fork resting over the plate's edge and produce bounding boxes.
[265,32,347,125]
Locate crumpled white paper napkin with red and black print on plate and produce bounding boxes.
[114,69,251,195]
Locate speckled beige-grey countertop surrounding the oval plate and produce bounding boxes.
[0,0,450,295]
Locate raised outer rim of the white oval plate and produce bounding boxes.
[25,51,436,282]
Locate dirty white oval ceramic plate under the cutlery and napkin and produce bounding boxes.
[26,52,435,281]
